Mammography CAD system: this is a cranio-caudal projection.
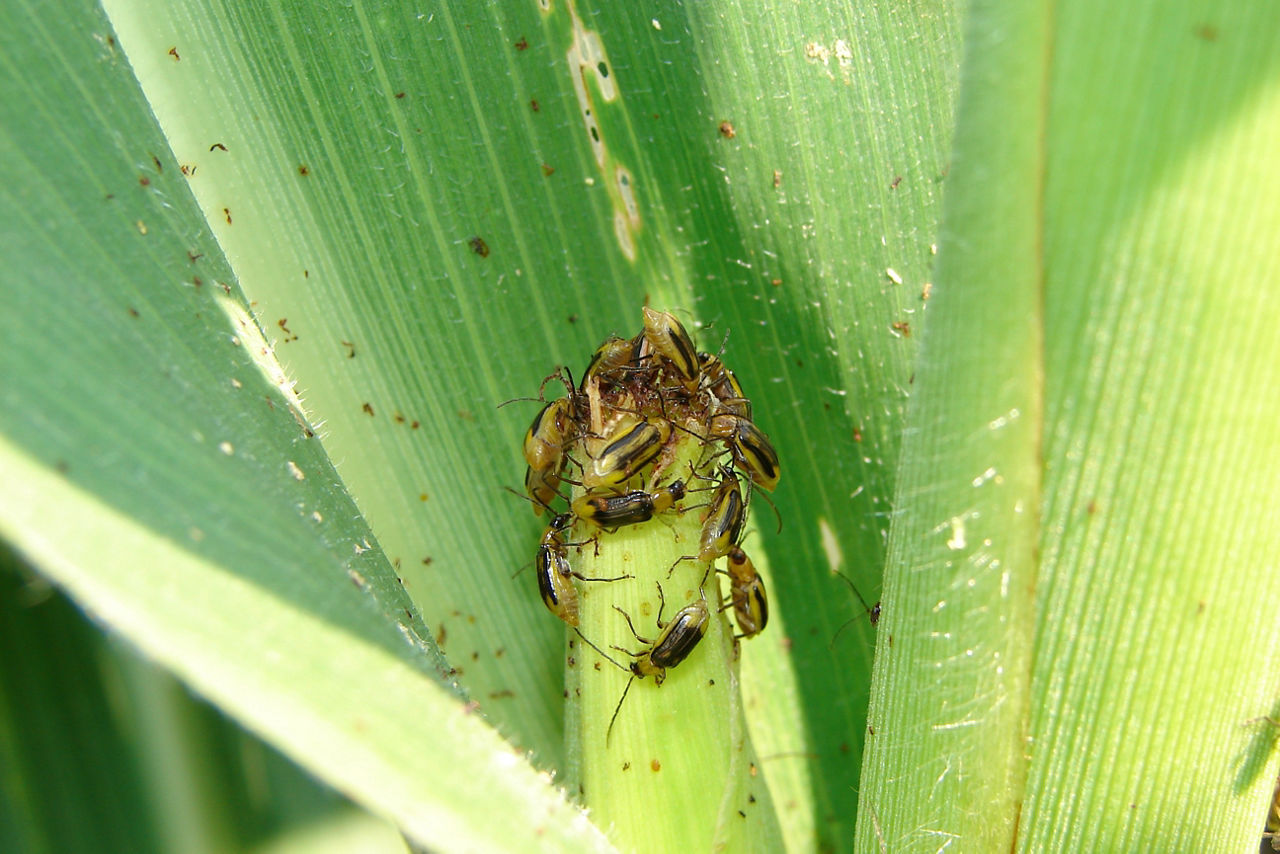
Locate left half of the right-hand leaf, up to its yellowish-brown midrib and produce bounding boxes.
[858,4,1048,850]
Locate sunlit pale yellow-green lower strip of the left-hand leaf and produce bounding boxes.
[0,442,609,851]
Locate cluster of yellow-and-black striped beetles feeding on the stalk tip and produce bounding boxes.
[512,307,780,737]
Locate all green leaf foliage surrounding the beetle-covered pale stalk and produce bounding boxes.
[0,0,1280,850]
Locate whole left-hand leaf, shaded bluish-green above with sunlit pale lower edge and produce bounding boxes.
[0,6,607,850]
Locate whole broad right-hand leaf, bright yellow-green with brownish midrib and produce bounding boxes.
[859,3,1280,851]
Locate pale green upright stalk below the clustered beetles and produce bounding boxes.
[566,431,782,851]
